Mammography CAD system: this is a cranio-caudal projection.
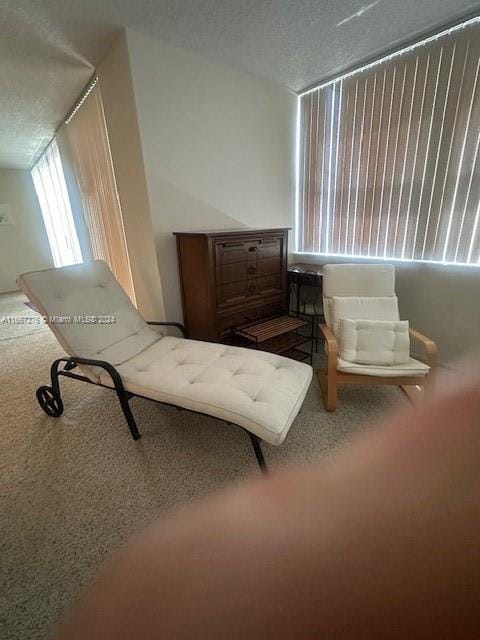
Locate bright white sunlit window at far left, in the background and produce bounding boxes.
[32,139,83,267]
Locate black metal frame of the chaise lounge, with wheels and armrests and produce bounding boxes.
[36,322,267,474]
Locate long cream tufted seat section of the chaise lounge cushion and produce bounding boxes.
[100,336,312,445]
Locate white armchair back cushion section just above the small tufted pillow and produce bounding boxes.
[331,296,400,338]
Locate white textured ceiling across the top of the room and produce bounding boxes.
[0,0,480,167]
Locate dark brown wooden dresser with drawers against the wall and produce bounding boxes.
[174,228,289,340]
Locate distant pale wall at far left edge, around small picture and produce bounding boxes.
[0,169,53,293]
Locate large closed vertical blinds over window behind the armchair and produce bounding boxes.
[297,23,480,264]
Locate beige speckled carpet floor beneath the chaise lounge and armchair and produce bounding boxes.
[0,295,404,640]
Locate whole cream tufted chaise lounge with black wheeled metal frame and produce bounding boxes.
[17,260,313,471]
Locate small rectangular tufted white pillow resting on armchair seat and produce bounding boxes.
[339,318,410,365]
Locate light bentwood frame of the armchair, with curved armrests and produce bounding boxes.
[317,324,437,411]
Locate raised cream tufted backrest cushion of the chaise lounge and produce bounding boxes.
[17,260,162,379]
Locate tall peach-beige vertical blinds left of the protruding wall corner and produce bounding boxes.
[64,82,135,303]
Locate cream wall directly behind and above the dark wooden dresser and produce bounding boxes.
[127,30,296,320]
